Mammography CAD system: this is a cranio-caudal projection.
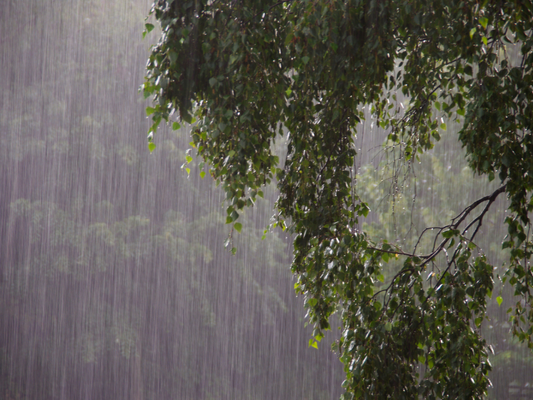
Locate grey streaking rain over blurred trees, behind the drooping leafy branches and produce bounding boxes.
[0,0,533,400]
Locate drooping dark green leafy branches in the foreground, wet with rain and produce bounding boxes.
[142,0,533,399]
